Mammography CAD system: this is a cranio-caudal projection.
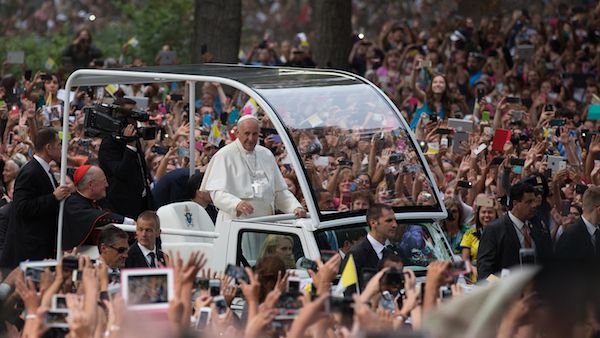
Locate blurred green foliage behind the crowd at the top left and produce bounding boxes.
[0,0,194,74]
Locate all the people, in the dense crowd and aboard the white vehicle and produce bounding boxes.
[0,0,600,337]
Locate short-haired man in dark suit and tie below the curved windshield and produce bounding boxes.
[342,204,398,289]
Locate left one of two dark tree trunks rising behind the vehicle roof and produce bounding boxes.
[191,0,242,63]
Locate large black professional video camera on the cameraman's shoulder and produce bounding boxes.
[83,104,157,141]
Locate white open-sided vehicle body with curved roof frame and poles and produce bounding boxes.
[57,65,451,271]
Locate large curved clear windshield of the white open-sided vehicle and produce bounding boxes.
[252,71,442,220]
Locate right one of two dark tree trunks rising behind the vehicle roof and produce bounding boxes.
[312,0,352,69]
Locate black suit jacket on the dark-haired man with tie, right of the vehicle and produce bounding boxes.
[477,214,553,280]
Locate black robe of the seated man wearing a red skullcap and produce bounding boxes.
[63,192,125,250]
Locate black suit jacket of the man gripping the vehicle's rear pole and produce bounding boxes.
[0,158,59,268]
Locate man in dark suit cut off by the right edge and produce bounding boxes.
[556,187,600,263]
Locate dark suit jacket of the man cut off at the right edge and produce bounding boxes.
[556,217,600,263]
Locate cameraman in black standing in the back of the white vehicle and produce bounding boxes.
[98,98,154,219]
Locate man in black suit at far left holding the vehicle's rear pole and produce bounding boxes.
[0,128,72,268]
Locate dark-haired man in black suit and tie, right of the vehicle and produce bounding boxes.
[477,183,553,280]
